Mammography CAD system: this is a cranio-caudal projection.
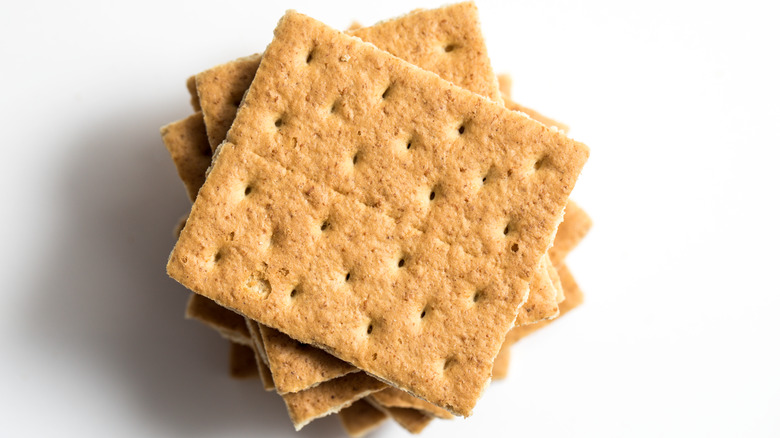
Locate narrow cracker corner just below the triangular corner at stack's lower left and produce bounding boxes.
[282,373,387,430]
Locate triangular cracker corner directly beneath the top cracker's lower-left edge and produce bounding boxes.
[259,326,358,394]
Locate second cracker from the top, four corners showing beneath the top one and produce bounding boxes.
[174,2,563,392]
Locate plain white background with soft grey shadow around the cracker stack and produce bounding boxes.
[0,0,780,437]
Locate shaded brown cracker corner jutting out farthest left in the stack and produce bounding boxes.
[160,112,211,201]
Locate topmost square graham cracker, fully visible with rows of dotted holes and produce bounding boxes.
[168,12,588,415]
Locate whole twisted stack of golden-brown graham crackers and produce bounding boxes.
[161,3,591,436]
